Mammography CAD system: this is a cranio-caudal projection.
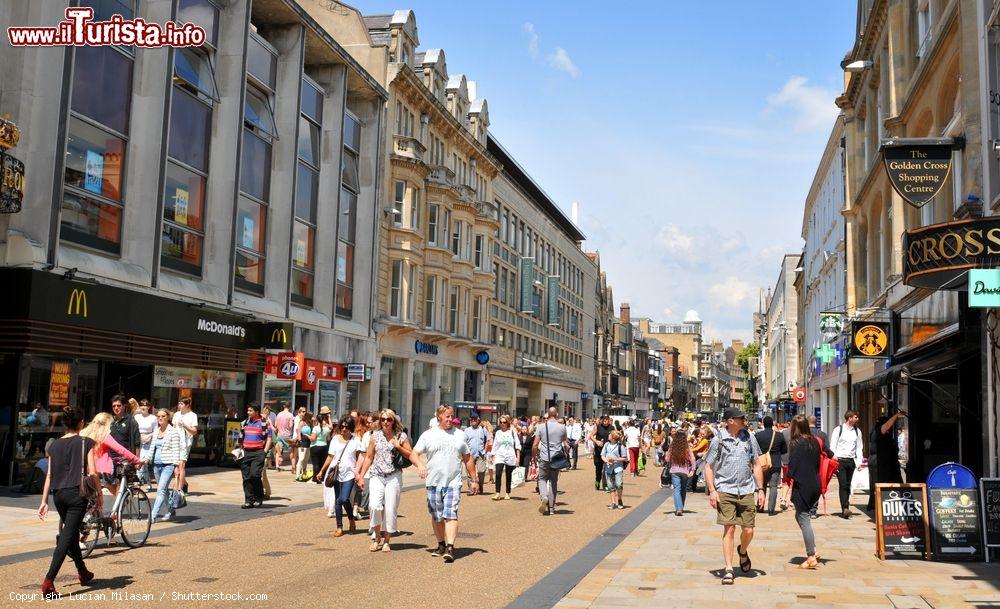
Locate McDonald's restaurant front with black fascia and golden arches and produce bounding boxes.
[0,268,293,485]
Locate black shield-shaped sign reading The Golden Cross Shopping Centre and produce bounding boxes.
[882,139,954,207]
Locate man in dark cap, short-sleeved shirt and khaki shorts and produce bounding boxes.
[705,408,764,584]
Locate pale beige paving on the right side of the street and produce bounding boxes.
[555,483,1000,609]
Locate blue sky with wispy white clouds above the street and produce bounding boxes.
[354,0,856,342]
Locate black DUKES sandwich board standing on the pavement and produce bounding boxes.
[875,484,930,559]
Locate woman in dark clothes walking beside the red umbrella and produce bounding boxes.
[788,415,820,569]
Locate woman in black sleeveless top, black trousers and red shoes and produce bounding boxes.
[38,406,98,600]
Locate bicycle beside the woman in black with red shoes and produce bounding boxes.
[80,463,153,558]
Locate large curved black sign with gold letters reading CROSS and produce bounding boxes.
[903,216,1000,290]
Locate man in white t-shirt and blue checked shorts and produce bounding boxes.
[410,406,479,562]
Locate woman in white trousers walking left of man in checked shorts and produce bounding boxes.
[358,408,412,552]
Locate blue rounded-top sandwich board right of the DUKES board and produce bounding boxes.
[928,488,983,560]
